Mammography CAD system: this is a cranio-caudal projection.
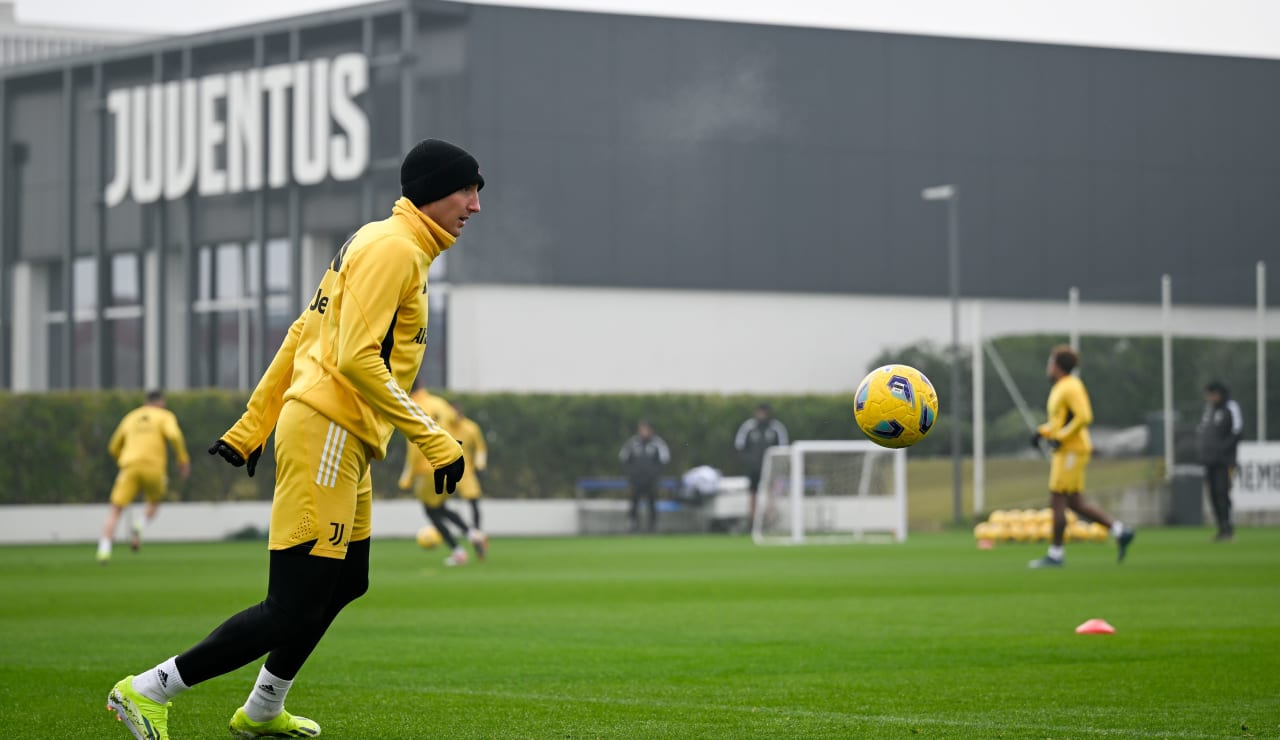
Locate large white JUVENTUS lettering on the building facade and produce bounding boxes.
[102,54,369,207]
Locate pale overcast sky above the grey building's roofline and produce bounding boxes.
[17,0,1280,59]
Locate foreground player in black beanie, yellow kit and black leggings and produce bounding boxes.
[108,140,484,740]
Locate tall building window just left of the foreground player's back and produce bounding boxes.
[192,239,293,389]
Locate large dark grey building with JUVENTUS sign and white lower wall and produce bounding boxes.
[0,0,1280,392]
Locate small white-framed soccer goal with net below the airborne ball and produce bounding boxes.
[751,440,906,544]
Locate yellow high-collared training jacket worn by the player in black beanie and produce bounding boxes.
[223,198,462,467]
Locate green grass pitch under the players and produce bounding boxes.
[0,525,1280,739]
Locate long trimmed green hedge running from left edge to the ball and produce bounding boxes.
[0,390,860,503]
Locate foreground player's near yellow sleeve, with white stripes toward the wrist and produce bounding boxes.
[337,242,462,467]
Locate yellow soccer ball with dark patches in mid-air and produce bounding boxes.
[854,365,938,447]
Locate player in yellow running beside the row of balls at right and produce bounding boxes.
[1029,344,1134,568]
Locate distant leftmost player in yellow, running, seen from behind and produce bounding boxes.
[97,390,191,563]
